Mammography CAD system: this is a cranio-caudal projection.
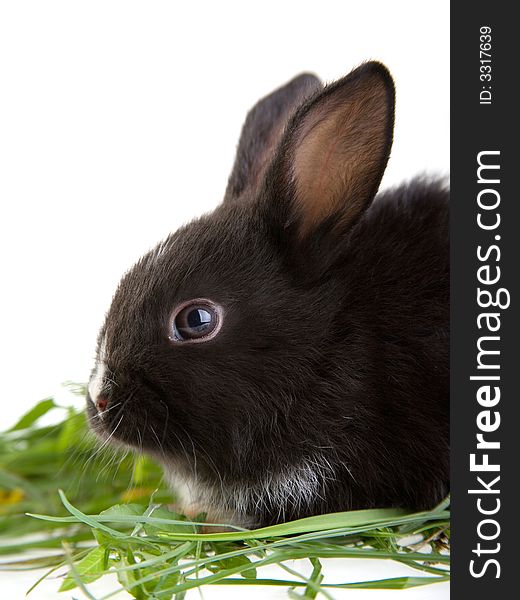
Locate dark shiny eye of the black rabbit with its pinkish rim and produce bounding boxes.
[169,299,223,342]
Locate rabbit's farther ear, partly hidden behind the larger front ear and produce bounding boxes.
[225,73,323,201]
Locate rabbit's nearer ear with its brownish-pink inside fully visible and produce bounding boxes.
[265,62,394,238]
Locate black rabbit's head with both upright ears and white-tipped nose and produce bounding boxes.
[87,62,406,524]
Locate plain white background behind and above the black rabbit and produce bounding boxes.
[0,0,449,600]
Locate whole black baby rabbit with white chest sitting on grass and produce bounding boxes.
[87,62,449,526]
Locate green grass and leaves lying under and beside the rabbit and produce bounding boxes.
[0,389,450,600]
